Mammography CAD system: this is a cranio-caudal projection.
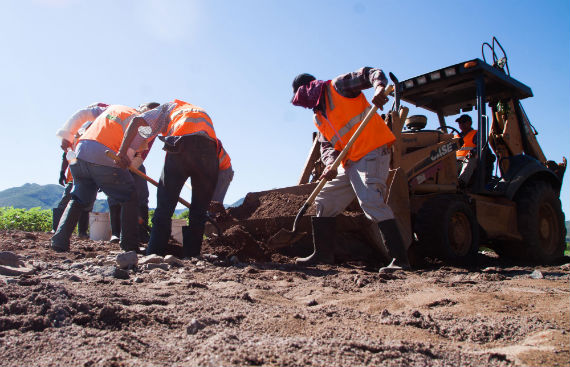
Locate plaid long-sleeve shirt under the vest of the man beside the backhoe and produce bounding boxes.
[315,67,388,166]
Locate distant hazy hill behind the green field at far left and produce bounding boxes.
[0,183,109,212]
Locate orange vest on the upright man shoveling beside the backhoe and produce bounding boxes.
[314,80,396,166]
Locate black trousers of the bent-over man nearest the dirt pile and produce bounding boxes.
[147,135,218,256]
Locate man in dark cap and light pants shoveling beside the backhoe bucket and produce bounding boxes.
[291,67,410,270]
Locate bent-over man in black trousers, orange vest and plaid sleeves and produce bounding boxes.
[119,99,219,257]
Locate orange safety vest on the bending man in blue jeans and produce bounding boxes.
[79,105,138,153]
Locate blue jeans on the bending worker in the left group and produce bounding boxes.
[52,159,138,251]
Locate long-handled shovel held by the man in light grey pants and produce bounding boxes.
[267,85,394,249]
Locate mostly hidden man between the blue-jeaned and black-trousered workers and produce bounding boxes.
[107,102,160,243]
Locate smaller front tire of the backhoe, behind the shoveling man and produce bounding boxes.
[414,195,479,265]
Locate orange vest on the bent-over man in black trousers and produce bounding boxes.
[164,99,216,140]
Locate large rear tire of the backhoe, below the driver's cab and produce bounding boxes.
[496,181,566,264]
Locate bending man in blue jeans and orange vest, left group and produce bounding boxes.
[51,105,139,252]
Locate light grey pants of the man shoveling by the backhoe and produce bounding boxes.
[315,146,394,223]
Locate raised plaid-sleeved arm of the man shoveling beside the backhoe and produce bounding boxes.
[332,66,388,109]
